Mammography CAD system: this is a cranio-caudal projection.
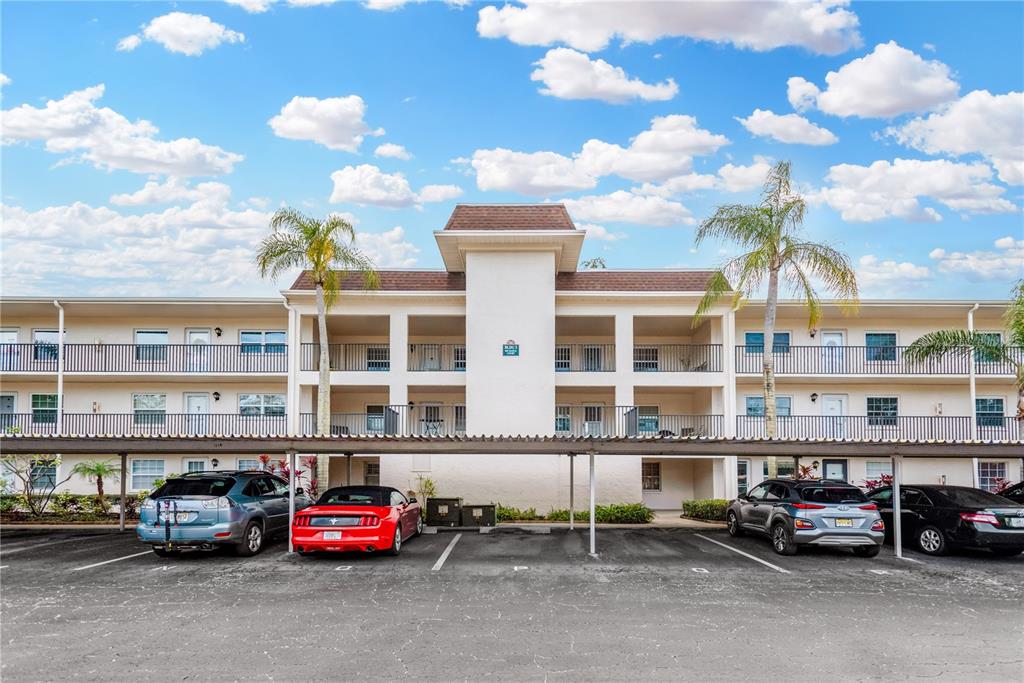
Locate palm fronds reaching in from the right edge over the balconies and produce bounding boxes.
[903,280,1024,420]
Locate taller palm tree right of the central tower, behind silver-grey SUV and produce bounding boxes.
[693,162,858,476]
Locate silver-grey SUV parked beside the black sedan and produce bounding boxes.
[725,479,885,557]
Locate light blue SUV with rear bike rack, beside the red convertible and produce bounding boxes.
[135,470,312,557]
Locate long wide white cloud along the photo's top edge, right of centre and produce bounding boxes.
[476,0,860,54]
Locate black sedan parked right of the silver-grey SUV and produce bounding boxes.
[867,484,1024,557]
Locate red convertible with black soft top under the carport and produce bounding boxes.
[292,486,423,555]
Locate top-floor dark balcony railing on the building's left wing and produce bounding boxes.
[0,343,288,373]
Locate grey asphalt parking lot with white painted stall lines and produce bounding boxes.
[0,527,1024,681]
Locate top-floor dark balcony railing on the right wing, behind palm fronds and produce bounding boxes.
[736,345,1024,375]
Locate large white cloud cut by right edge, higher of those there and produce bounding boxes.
[886,90,1024,185]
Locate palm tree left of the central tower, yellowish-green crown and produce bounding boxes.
[256,209,380,434]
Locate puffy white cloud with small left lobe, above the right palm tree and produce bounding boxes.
[787,41,959,118]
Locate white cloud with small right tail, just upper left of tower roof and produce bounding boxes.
[330,164,462,208]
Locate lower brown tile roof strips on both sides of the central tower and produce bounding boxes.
[292,270,715,292]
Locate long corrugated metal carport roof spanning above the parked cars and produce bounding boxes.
[0,434,1024,458]
